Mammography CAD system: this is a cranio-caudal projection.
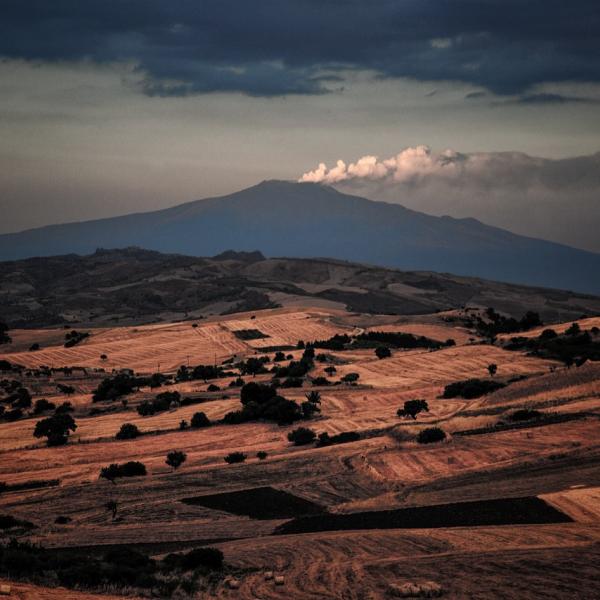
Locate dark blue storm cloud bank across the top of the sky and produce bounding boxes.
[0,0,600,96]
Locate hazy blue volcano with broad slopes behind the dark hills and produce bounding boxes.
[0,181,600,293]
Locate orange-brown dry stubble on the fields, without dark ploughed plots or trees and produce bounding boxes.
[0,308,600,600]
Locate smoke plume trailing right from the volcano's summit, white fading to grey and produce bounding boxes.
[299,146,600,252]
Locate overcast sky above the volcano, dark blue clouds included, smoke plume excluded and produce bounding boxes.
[0,0,600,251]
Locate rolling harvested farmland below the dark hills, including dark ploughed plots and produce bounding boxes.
[0,308,600,600]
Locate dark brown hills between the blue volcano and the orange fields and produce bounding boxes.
[0,248,600,327]
